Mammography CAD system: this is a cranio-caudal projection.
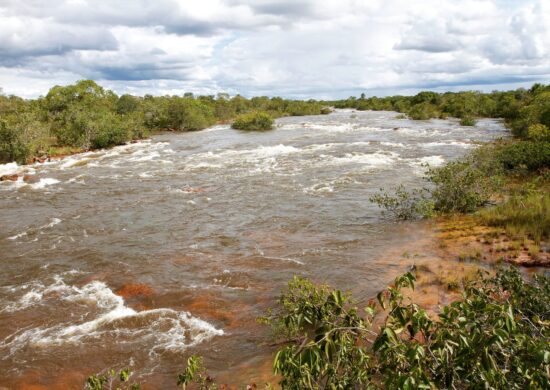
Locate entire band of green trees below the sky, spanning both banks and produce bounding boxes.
[0,80,550,163]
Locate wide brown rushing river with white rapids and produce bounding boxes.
[0,110,505,388]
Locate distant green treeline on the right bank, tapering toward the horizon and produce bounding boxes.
[330,84,550,138]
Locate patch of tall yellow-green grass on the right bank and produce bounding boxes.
[478,192,550,244]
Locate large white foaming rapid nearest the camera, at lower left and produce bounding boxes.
[0,276,224,359]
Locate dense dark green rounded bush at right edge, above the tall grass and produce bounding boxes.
[499,141,550,171]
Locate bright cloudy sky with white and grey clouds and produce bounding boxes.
[0,0,550,99]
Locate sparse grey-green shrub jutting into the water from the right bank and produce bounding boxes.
[369,185,433,220]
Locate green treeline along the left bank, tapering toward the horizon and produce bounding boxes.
[0,80,330,163]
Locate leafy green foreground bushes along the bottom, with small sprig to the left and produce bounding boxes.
[92,269,550,390]
